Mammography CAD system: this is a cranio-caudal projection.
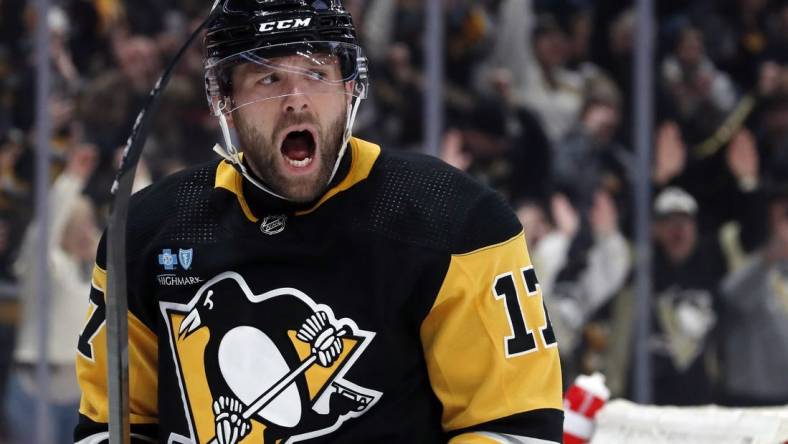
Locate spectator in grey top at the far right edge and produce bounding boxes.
[722,185,788,406]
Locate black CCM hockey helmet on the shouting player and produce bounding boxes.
[204,0,368,115]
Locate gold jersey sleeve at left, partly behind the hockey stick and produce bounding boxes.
[74,234,158,444]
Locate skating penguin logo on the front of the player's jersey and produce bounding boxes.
[160,272,382,444]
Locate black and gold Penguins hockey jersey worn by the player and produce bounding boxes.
[75,139,563,443]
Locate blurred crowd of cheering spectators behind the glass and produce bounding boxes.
[0,0,788,440]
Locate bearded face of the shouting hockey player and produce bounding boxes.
[231,56,350,202]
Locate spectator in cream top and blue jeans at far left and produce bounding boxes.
[5,147,99,443]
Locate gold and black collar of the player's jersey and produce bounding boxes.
[214,138,380,222]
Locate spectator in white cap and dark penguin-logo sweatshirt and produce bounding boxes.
[649,187,726,405]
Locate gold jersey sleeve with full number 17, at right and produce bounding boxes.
[420,193,563,444]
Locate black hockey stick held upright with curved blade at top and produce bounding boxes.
[107,0,222,444]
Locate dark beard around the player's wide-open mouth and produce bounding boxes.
[233,106,347,202]
